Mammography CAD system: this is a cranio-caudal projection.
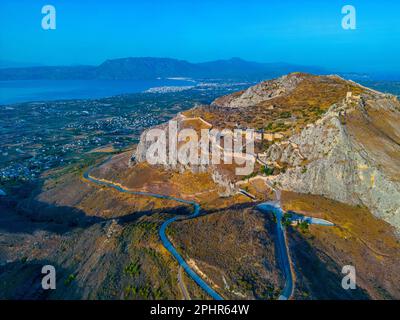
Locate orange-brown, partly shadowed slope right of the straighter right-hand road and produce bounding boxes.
[282,192,400,299]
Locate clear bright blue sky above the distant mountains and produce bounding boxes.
[0,0,400,72]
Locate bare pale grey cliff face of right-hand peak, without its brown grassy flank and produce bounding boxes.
[267,96,400,231]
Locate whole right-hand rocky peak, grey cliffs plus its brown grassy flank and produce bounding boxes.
[266,91,400,229]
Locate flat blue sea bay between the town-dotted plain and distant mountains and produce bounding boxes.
[0,78,196,105]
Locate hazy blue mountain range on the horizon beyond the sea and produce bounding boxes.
[0,57,330,80]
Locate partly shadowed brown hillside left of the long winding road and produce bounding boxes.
[0,158,203,299]
